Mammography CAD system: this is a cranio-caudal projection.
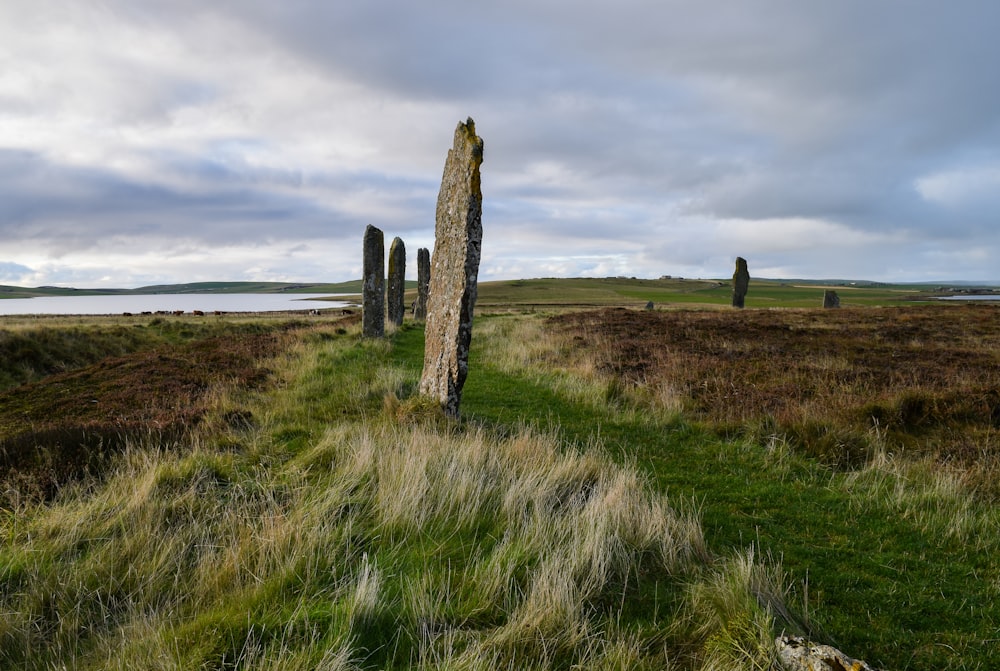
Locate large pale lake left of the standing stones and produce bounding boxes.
[0,294,348,315]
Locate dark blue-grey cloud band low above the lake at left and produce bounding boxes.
[0,151,433,252]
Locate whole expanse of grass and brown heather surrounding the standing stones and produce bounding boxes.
[0,280,1000,669]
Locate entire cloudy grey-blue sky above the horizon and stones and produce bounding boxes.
[0,0,1000,287]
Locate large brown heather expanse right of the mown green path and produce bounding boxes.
[552,305,1000,496]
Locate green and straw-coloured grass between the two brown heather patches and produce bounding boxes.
[0,314,1000,669]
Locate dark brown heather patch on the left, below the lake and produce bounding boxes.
[0,330,291,498]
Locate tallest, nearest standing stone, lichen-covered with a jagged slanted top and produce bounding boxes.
[420,119,483,417]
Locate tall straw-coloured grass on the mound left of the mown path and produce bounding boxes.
[0,318,796,669]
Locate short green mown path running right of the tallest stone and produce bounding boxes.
[463,317,1000,669]
